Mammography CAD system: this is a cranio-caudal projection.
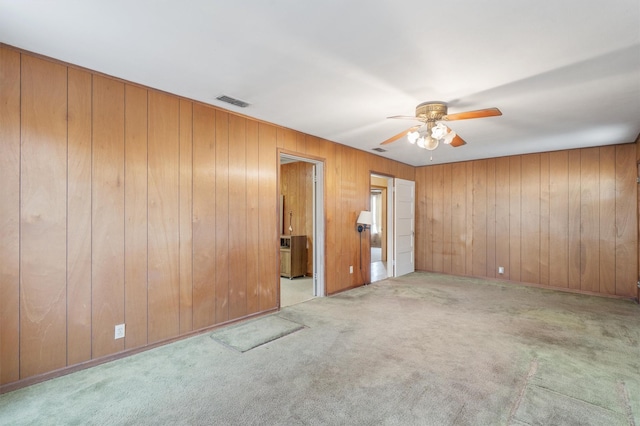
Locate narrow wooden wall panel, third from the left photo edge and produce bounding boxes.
[67,68,92,365]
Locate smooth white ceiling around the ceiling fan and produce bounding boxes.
[0,0,640,166]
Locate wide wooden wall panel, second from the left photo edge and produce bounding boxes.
[20,56,67,378]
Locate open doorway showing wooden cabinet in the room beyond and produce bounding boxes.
[278,154,325,308]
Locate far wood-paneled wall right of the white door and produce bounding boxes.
[416,148,638,297]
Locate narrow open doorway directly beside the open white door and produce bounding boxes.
[370,173,393,282]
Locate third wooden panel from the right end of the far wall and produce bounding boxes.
[580,148,600,292]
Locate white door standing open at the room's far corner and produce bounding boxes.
[393,179,416,277]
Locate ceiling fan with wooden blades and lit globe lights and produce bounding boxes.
[380,101,502,151]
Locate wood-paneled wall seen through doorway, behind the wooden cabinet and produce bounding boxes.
[280,161,314,276]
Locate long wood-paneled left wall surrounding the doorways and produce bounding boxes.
[0,45,414,389]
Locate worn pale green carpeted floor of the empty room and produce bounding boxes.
[0,273,640,425]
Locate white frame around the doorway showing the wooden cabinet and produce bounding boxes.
[274,149,327,302]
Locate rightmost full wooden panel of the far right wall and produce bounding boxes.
[616,144,638,297]
